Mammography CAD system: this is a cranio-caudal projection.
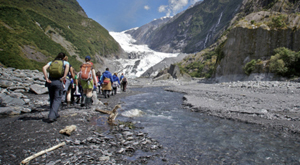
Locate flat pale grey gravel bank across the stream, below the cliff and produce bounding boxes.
[161,81,300,134]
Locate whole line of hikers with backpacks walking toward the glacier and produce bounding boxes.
[43,53,127,122]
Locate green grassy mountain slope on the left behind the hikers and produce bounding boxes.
[0,0,122,71]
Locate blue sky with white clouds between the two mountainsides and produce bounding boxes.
[77,0,199,32]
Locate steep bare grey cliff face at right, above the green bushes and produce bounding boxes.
[215,10,300,81]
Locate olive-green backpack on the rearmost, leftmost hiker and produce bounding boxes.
[48,60,65,79]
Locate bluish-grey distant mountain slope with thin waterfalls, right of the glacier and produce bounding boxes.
[130,0,243,53]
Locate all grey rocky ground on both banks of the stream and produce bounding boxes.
[0,66,300,165]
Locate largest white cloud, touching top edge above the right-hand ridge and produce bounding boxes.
[158,0,188,16]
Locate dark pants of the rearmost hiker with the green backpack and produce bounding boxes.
[48,80,64,120]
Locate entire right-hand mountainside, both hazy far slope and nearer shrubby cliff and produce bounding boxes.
[130,0,300,82]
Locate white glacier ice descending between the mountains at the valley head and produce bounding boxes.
[109,31,178,78]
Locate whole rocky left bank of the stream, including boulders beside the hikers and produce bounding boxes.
[0,68,165,165]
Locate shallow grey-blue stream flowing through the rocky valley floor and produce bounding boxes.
[123,87,300,165]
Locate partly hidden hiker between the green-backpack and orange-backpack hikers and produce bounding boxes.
[61,56,75,107]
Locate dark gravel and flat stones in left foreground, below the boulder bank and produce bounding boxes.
[0,90,166,165]
